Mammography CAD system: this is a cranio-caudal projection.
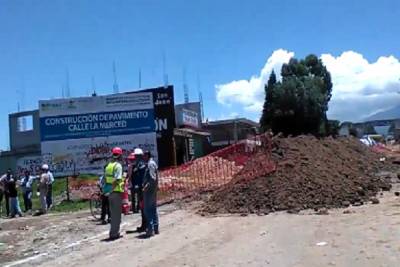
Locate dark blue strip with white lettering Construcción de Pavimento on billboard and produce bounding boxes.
[40,109,155,142]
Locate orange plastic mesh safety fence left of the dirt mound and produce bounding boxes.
[69,135,275,204]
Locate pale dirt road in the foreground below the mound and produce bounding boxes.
[3,185,400,267]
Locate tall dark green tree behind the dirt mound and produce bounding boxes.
[260,55,337,136]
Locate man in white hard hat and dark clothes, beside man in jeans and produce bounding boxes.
[131,148,147,233]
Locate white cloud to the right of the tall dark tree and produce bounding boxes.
[321,51,400,121]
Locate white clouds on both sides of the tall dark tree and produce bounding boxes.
[216,49,400,121]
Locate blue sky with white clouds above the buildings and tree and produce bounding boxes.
[0,0,400,149]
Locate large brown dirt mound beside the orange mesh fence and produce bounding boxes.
[202,136,390,214]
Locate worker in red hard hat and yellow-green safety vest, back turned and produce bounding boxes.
[105,147,124,241]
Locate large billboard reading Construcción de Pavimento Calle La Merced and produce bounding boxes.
[39,92,157,176]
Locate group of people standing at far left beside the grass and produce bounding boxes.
[0,164,54,218]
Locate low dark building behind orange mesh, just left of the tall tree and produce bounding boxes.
[203,118,260,150]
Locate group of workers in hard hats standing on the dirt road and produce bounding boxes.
[100,147,159,240]
